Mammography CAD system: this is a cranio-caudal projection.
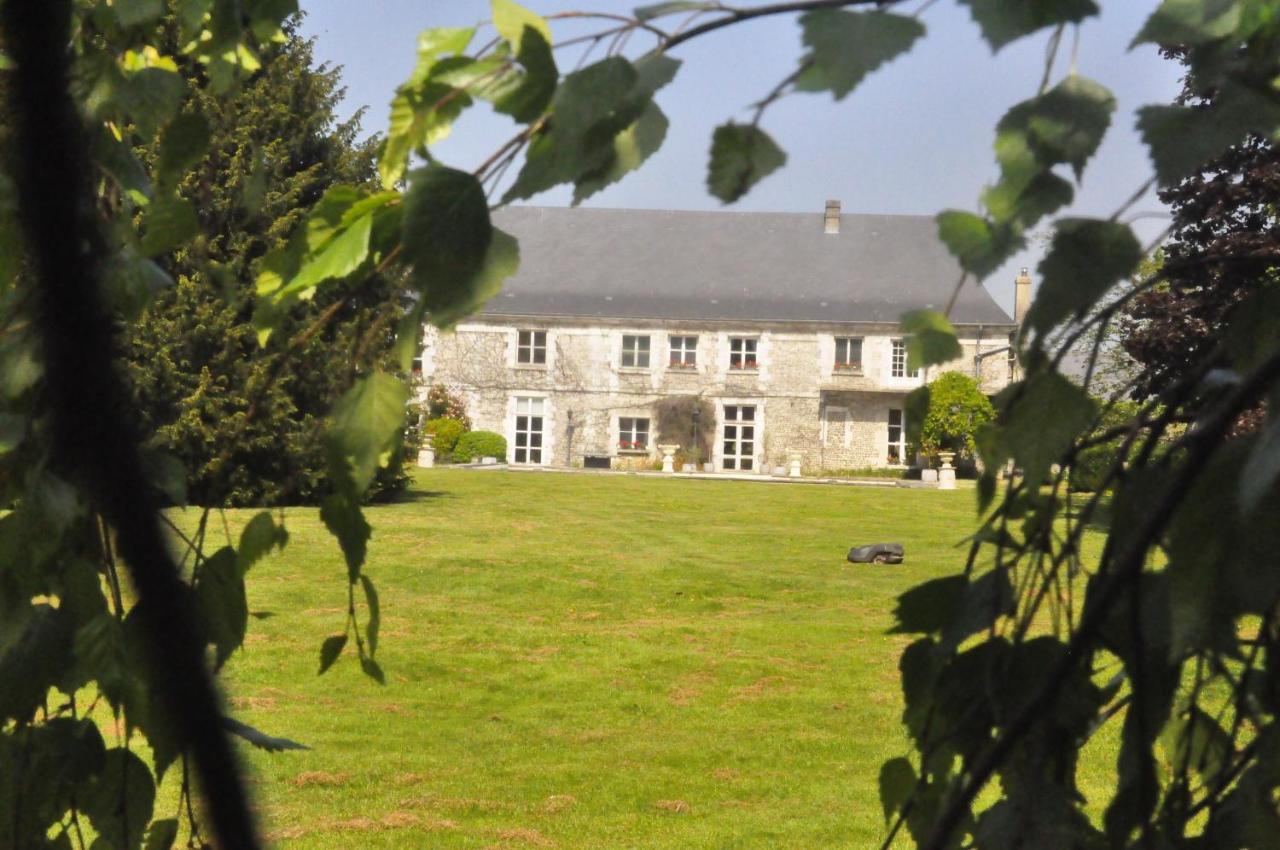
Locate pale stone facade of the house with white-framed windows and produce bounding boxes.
[421,316,1012,472]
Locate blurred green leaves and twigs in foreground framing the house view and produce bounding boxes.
[0,0,1280,850]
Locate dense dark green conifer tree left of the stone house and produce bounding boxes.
[124,22,407,507]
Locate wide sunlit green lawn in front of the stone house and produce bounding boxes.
[202,470,1111,847]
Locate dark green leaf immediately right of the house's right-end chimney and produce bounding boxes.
[1027,219,1142,334]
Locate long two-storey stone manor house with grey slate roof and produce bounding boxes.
[420,201,1030,472]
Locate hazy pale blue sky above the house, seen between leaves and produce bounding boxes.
[302,0,1179,310]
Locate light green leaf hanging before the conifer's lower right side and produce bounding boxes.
[329,371,408,498]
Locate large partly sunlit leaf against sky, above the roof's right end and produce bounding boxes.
[996,74,1116,180]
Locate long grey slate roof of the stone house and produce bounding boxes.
[483,206,1012,326]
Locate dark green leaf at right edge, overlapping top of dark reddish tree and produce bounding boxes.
[1138,84,1280,186]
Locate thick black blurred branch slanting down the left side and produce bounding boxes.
[0,0,259,850]
